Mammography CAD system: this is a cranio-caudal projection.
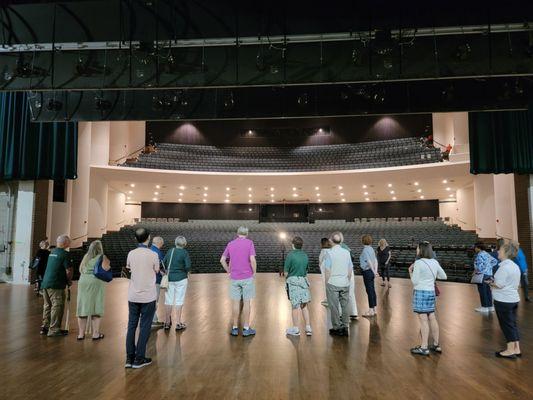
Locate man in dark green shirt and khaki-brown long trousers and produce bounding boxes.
[41,235,72,337]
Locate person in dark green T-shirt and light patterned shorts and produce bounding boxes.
[285,236,313,336]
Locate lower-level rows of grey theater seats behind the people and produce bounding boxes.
[80,218,477,282]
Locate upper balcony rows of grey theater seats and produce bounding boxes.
[122,137,442,172]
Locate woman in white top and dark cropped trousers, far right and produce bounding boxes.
[491,241,522,359]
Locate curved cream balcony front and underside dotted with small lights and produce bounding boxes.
[91,162,473,204]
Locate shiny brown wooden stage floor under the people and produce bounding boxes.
[0,274,533,400]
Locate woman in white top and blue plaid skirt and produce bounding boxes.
[409,242,447,356]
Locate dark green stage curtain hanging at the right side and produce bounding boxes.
[468,107,533,174]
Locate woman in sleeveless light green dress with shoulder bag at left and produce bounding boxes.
[76,240,111,340]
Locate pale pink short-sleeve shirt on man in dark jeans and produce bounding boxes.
[126,246,159,303]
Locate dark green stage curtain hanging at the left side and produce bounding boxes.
[0,92,78,180]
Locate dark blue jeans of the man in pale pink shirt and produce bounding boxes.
[126,301,155,359]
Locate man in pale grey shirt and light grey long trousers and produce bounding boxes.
[323,232,353,336]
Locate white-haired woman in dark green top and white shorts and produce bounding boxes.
[163,236,191,331]
